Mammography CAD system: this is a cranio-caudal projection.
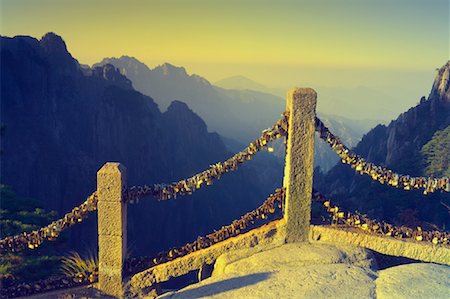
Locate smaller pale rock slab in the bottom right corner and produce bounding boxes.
[376,263,450,299]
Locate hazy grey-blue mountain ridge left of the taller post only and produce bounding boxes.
[94,56,284,143]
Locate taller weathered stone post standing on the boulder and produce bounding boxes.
[283,88,317,243]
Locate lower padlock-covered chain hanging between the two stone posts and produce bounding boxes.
[125,188,286,273]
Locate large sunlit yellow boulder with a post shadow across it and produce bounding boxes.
[161,243,377,299]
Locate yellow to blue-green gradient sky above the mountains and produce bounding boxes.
[1,0,449,91]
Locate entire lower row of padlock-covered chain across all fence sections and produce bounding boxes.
[1,188,450,297]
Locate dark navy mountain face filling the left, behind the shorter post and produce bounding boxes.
[1,33,282,254]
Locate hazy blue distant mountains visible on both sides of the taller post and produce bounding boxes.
[93,56,375,171]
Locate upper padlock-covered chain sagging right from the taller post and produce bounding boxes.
[315,117,450,194]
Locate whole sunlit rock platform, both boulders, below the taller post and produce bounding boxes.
[159,243,450,299]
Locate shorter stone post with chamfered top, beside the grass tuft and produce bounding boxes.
[97,162,127,298]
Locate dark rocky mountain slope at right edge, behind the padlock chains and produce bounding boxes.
[317,62,450,227]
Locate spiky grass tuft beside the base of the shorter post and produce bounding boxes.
[61,251,98,282]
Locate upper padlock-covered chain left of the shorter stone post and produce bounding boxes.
[0,192,98,254]
